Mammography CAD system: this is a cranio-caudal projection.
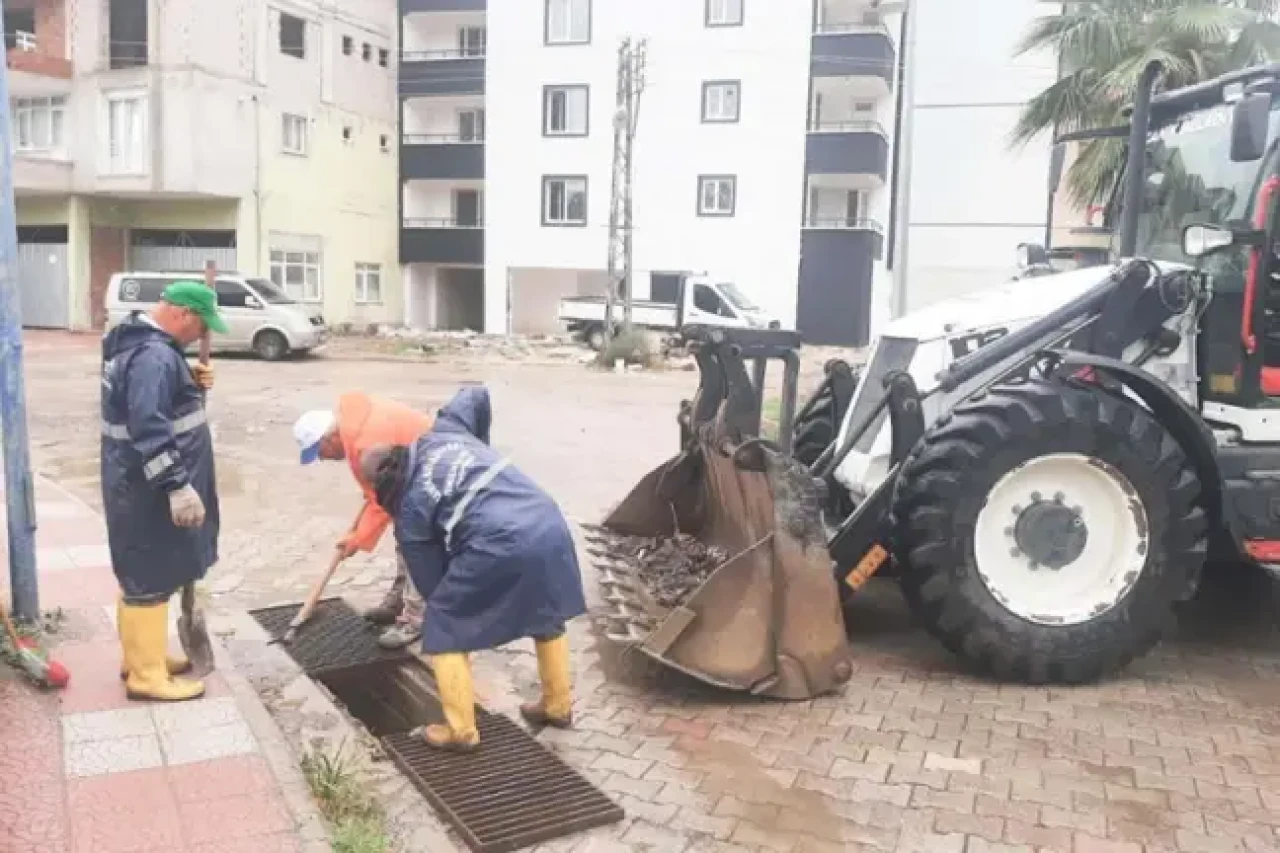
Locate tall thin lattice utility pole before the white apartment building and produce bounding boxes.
[604,38,645,345]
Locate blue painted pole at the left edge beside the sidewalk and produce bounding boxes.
[0,0,40,621]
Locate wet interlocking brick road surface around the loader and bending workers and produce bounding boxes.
[20,335,1280,853]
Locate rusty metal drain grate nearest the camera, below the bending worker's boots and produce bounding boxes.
[383,706,623,853]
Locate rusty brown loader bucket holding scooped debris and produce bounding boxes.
[586,333,852,699]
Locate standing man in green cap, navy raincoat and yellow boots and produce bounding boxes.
[102,282,227,701]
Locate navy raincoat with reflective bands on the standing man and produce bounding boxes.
[102,311,219,603]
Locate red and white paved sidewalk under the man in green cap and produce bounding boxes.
[0,478,329,853]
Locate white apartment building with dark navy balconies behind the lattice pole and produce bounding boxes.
[399,0,1052,345]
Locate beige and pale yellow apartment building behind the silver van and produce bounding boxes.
[4,0,403,328]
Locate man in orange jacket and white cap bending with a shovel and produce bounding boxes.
[293,392,435,649]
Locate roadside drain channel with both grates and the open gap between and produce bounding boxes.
[252,598,623,853]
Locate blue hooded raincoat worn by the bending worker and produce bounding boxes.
[396,387,586,654]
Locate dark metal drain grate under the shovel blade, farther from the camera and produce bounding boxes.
[250,598,411,676]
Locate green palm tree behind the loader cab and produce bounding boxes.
[1012,0,1280,205]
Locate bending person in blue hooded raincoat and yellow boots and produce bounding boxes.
[361,387,586,751]
